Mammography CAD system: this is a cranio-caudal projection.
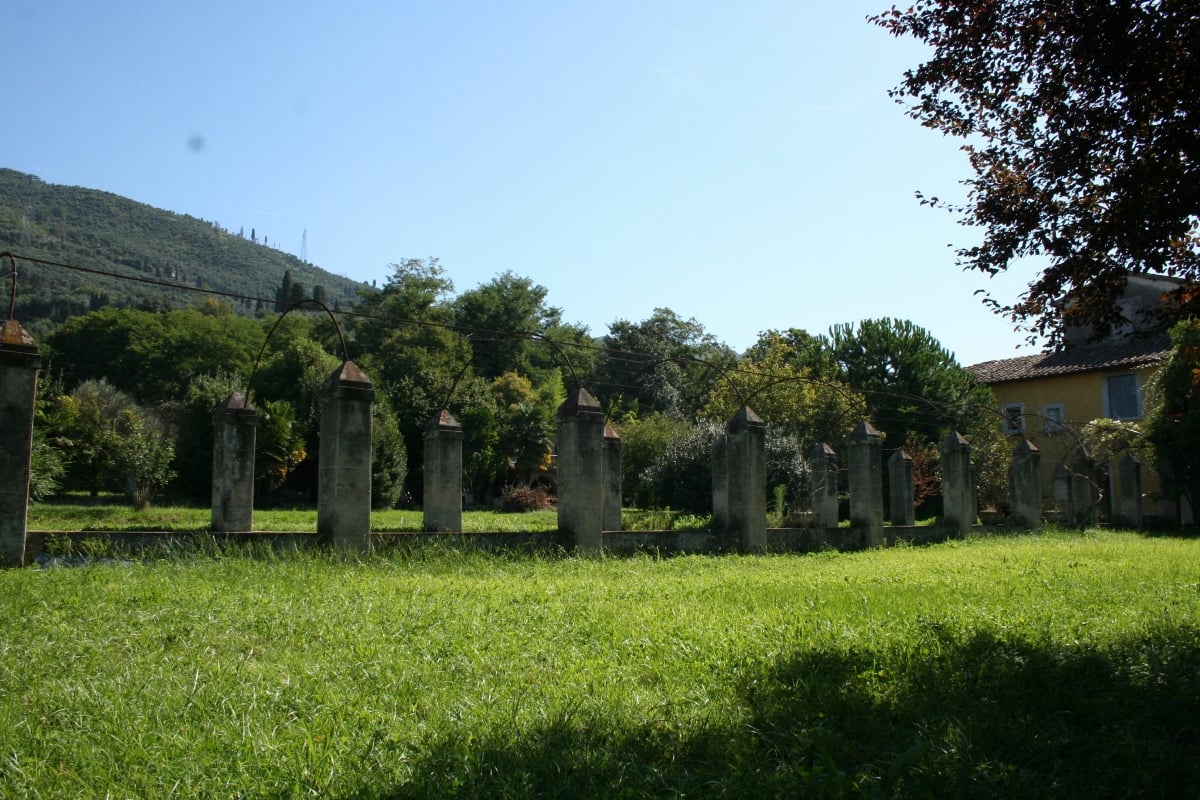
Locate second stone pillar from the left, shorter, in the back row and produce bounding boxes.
[212,392,258,534]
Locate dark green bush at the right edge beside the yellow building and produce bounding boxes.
[1145,320,1200,509]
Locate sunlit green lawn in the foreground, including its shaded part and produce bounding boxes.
[0,531,1200,798]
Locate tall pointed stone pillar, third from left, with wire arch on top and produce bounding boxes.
[317,361,374,553]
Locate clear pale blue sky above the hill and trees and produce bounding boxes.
[0,0,1032,363]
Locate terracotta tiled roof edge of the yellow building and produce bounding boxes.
[967,335,1171,384]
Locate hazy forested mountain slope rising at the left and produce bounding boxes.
[0,168,365,335]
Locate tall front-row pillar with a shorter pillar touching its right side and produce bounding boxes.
[557,387,604,554]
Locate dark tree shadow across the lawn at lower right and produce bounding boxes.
[348,624,1200,799]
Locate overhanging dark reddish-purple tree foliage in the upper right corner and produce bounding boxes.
[871,0,1200,341]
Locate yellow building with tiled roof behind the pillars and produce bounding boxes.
[968,336,1175,518]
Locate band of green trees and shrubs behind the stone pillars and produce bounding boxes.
[28,259,997,512]
